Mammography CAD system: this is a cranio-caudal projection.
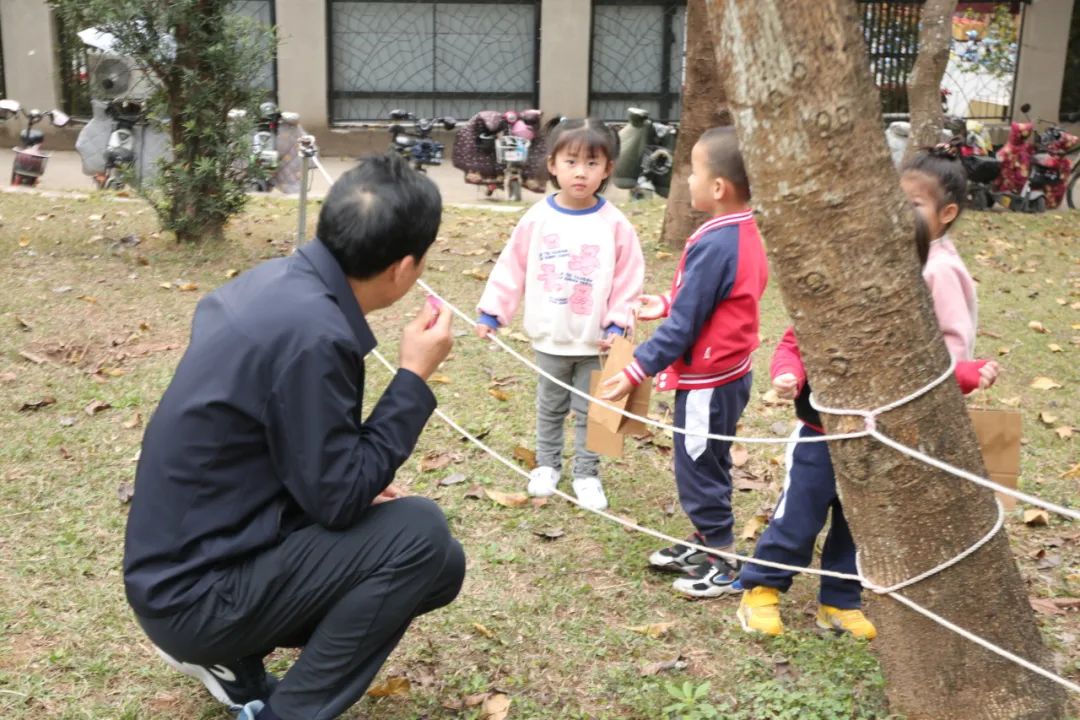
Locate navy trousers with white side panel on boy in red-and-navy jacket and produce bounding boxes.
[674,373,753,547]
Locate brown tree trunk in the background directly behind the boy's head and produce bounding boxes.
[661,0,731,247]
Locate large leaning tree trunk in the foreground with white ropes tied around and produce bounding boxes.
[706,0,1065,720]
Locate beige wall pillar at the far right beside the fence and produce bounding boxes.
[1013,0,1074,120]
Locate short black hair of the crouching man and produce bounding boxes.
[316,154,443,280]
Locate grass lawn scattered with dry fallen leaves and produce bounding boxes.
[0,188,1080,720]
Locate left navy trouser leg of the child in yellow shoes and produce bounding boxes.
[739,424,847,604]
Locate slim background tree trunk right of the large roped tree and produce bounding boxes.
[904,0,956,161]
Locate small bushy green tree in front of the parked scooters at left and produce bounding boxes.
[49,0,273,242]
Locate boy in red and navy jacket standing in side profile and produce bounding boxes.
[600,127,768,597]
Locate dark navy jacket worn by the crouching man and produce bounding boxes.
[124,240,435,617]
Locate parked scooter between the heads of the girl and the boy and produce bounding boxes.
[613,108,677,200]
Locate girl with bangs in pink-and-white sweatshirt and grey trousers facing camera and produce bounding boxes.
[476,119,645,510]
